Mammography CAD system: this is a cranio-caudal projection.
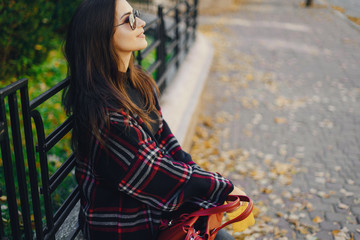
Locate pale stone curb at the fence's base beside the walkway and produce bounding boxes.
[160,32,214,150]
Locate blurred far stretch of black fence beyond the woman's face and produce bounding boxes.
[136,0,198,90]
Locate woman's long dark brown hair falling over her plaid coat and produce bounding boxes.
[63,0,159,158]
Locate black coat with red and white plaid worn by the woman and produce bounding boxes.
[76,109,233,240]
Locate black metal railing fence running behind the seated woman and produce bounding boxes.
[0,0,198,239]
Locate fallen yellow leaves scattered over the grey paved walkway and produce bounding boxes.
[195,5,360,240]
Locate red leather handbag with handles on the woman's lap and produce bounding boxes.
[158,195,254,240]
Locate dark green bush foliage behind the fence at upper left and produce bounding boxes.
[0,0,80,81]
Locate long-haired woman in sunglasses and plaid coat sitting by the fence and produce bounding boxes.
[63,0,243,240]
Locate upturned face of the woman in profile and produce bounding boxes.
[113,0,147,58]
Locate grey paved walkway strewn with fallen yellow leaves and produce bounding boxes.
[191,0,360,239]
